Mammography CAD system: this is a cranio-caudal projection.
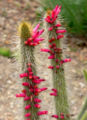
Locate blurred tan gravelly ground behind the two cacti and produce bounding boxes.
[0,0,87,120]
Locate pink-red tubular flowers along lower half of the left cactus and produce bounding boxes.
[16,64,48,120]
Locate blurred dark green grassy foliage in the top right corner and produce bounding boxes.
[38,0,87,35]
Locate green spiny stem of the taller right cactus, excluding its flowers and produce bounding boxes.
[44,15,70,120]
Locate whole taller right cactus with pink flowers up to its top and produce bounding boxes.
[41,5,71,120]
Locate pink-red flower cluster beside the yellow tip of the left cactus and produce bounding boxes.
[25,24,44,46]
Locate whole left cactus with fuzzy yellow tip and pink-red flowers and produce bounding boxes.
[16,22,48,120]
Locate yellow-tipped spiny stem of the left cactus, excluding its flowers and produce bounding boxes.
[19,22,38,120]
